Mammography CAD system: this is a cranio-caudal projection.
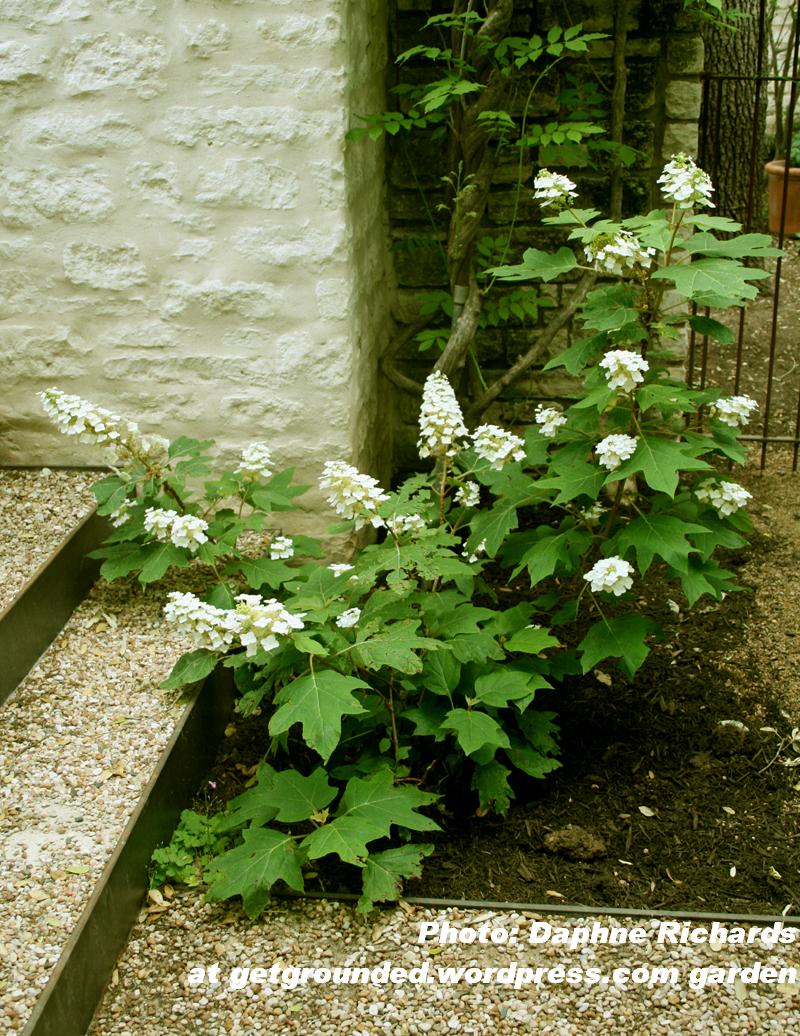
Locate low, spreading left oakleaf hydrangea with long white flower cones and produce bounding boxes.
[42,385,559,915]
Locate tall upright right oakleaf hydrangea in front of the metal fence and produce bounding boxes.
[480,154,781,677]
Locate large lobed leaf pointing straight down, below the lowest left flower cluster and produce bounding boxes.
[269,669,369,762]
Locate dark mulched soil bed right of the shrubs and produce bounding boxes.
[166,458,800,915]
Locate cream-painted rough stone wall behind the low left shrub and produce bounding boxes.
[0,0,387,511]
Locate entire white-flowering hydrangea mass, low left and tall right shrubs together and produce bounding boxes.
[41,155,779,917]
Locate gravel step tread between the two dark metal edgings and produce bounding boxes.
[0,582,200,1031]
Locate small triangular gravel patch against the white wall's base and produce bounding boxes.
[0,467,97,611]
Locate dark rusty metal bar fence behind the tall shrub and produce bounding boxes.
[688,0,800,471]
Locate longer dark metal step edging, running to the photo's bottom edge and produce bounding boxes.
[23,667,234,1036]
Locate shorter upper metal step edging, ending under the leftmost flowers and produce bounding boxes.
[0,512,109,703]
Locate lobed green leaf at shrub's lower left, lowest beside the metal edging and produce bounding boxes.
[207,828,305,918]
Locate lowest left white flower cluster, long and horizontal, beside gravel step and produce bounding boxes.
[164,592,304,655]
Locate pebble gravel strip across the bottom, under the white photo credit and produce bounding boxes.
[88,893,800,1036]
